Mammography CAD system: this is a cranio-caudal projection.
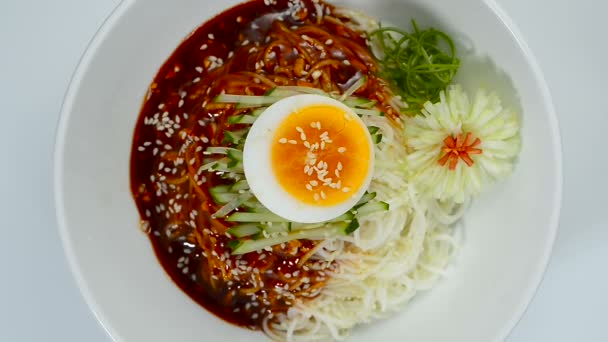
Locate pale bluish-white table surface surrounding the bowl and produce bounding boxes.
[0,0,608,342]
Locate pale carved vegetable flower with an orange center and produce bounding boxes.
[405,85,520,203]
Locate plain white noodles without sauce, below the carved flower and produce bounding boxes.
[263,117,467,341]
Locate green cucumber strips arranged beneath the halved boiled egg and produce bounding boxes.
[204,77,389,254]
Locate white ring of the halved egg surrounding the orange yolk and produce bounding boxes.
[243,94,375,223]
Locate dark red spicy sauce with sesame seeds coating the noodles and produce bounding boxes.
[131,0,388,328]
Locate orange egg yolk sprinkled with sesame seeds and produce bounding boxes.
[271,104,372,206]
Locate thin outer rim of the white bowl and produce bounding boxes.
[53,0,564,341]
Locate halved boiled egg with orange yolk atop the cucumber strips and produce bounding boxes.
[243,94,374,223]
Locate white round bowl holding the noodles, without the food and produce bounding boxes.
[55,0,562,342]
